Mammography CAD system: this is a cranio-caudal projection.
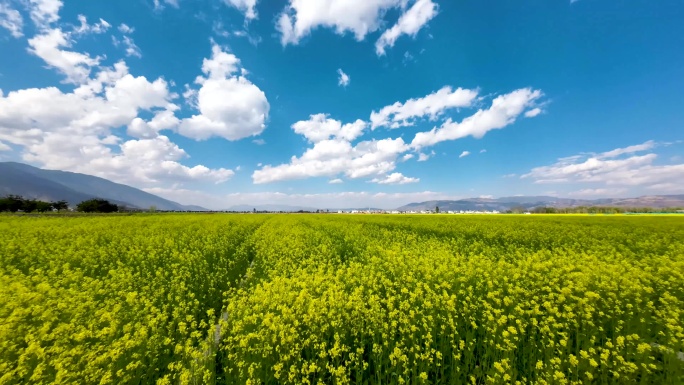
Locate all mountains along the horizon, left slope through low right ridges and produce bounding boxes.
[0,162,684,212]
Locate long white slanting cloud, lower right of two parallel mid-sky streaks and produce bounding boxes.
[411,88,542,148]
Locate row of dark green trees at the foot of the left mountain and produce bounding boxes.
[0,195,120,213]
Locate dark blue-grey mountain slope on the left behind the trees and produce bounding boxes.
[0,162,207,211]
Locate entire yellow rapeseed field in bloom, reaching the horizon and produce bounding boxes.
[0,214,684,385]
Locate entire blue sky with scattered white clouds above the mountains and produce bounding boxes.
[0,0,684,209]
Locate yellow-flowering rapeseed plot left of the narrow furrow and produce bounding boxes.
[0,215,265,384]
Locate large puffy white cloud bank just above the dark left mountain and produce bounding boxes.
[0,70,233,185]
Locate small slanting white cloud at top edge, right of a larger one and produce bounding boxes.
[375,0,438,56]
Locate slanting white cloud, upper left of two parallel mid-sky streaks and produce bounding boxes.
[370,86,478,129]
